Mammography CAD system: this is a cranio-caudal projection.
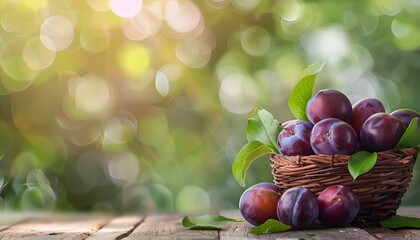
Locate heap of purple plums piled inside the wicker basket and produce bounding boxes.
[277,89,420,156]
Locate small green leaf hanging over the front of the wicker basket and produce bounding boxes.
[347,151,378,180]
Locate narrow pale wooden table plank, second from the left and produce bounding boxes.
[86,216,143,240]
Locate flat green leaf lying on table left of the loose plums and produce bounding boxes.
[182,215,244,230]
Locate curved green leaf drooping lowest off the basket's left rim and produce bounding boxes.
[232,141,272,187]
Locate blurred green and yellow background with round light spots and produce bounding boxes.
[0,0,420,213]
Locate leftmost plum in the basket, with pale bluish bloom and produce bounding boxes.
[277,120,314,156]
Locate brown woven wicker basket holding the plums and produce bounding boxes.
[270,147,419,222]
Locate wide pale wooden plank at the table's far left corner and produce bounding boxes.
[0,213,112,240]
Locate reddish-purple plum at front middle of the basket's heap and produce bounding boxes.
[310,118,357,155]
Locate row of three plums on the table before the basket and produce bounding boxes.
[239,183,360,229]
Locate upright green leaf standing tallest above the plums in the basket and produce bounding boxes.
[289,61,325,121]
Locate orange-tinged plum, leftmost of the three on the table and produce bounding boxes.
[239,183,281,226]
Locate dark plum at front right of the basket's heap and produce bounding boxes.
[360,113,405,152]
